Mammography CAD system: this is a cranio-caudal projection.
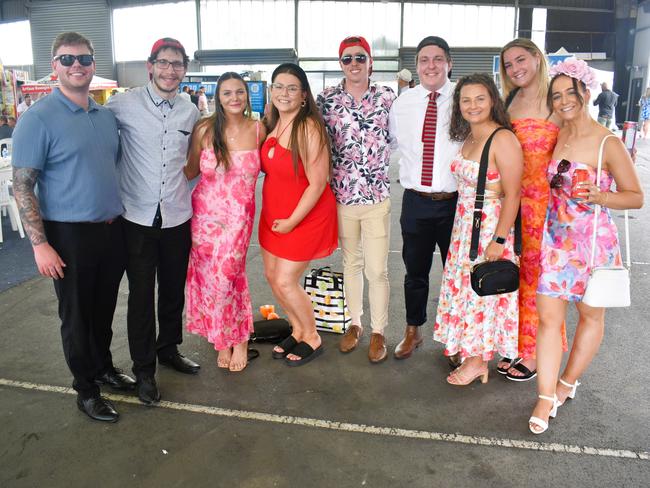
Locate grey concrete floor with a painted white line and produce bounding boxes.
[0,135,650,488]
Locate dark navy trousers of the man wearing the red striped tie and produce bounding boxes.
[400,190,458,326]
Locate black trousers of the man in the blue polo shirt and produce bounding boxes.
[44,218,126,398]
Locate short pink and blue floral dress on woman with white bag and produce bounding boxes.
[537,160,622,302]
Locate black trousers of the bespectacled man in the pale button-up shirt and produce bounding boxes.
[124,220,192,377]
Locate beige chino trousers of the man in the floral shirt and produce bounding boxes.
[336,198,390,334]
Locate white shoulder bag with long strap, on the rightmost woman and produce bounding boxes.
[582,135,631,307]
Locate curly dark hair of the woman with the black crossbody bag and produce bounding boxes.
[449,73,512,142]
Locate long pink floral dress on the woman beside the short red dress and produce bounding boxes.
[185,143,260,351]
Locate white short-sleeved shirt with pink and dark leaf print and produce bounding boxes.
[317,80,396,205]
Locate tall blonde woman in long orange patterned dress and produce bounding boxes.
[497,38,566,381]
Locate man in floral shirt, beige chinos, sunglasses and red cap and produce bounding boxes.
[317,36,395,363]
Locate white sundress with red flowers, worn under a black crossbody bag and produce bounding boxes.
[433,153,519,361]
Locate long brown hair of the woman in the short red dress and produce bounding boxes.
[264,63,331,174]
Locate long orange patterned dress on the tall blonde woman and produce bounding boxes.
[512,118,566,359]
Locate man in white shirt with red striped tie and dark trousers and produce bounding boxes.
[389,36,460,359]
